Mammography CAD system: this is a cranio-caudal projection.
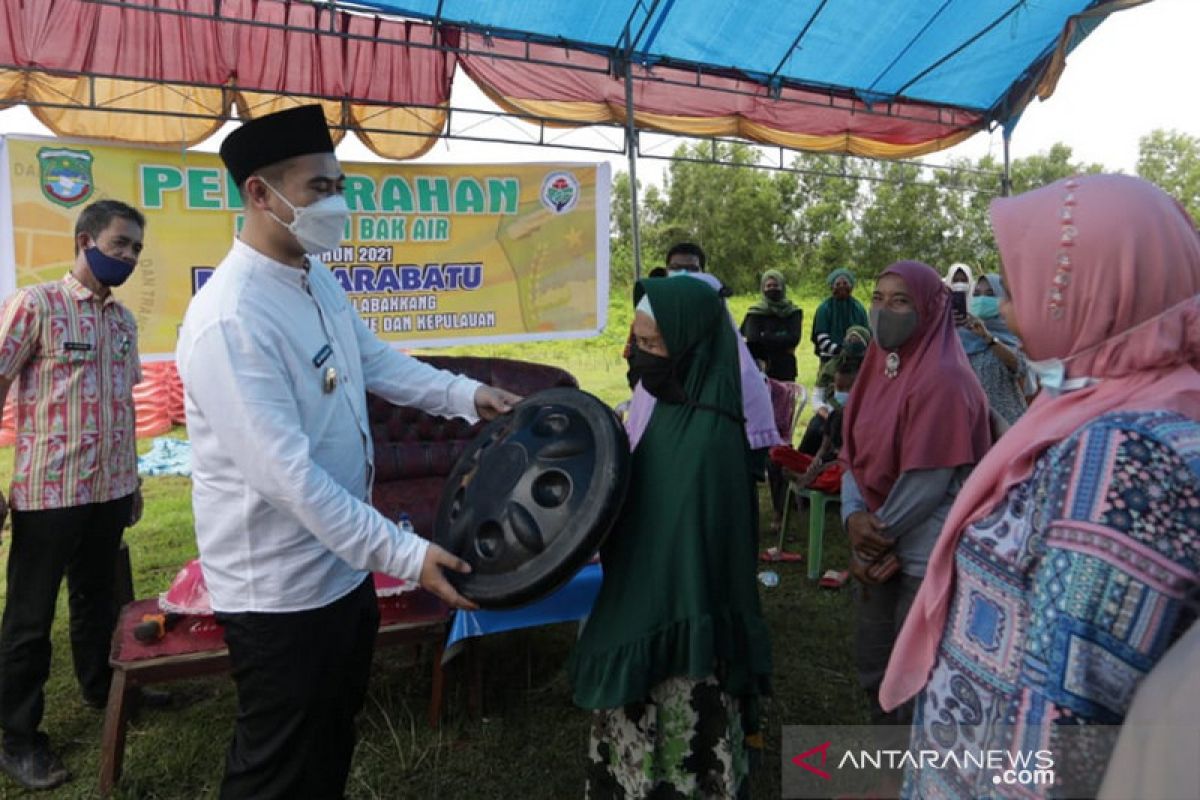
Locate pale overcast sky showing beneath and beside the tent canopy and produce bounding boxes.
[0,0,1200,182]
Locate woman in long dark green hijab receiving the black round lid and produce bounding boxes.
[569,278,770,799]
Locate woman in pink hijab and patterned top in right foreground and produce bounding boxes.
[880,175,1200,798]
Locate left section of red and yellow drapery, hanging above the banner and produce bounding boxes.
[0,0,455,158]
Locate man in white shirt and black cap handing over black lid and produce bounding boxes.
[176,106,520,799]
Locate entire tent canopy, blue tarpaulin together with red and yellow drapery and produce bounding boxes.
[0,0,1146,158]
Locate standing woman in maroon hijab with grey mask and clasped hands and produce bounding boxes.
[841,261,991,722]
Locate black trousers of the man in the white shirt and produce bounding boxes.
[216,576,379,800]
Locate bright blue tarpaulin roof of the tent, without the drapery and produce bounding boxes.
[356,0,1141,122]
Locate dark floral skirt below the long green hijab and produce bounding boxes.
[586,676,749,800]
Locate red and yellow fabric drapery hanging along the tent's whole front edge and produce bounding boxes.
[0,0,984,158]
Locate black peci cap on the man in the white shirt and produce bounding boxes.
[221,104,334,186]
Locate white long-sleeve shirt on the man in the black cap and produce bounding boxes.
[176,240,479,613]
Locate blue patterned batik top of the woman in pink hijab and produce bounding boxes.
[904,411,1200,799]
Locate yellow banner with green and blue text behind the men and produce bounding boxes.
[0,136,610,357]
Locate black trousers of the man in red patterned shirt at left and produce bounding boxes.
[0,495,133,752]
